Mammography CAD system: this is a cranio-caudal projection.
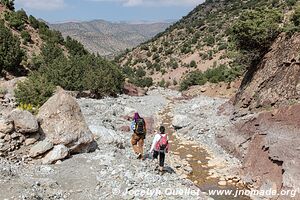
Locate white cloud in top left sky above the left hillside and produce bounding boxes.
[15,0,65,10]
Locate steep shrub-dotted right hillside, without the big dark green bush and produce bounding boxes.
[117,0,295,89]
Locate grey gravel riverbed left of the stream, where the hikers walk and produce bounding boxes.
[0,90,209,199]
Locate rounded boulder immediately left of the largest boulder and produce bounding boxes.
[9,109,39,133]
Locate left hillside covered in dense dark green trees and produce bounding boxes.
[0,0,124,107]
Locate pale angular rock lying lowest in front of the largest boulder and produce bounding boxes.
[42,144,69,164]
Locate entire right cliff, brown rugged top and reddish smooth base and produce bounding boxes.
[218,33,300,199]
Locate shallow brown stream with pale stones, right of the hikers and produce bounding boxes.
[159,100,250,200]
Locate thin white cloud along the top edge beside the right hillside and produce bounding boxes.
[89,0,204,7]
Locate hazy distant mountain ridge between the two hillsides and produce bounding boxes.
[50,20,172,56]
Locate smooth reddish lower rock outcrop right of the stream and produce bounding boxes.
[217,105,300,198]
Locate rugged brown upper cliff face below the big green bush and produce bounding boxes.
[234,33,300,110]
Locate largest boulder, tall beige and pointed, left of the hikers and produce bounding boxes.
[38,90,96,153]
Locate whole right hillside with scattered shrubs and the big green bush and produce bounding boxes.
[117,0,299,89]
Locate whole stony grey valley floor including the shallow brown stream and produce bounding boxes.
[0,89,294,200]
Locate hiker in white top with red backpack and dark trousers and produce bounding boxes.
[149,126,170,174]
